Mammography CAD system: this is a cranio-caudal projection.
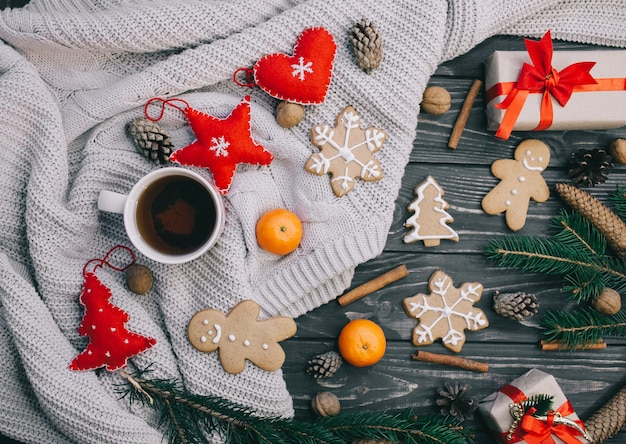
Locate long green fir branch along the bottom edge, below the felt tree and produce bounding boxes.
[118,370,473,444]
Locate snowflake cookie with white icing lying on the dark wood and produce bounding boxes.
[402,270,489,353]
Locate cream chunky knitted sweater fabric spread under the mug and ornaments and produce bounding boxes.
[0,0,626,444]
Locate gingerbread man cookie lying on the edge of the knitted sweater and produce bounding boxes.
[187,300,296,374]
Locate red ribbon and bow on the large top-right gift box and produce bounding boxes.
[486,31,626,139]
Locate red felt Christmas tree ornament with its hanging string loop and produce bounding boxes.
[69,245,156,371]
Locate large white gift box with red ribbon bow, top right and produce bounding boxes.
[485,31,626,139]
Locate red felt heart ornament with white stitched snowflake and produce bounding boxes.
[253,28,337,105]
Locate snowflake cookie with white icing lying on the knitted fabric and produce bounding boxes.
[304,106,387,197]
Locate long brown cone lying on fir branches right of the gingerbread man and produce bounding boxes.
[555,183,626,259]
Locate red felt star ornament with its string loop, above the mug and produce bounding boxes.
[144,96,274,194]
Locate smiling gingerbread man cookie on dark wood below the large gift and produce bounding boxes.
[482,139,550,231]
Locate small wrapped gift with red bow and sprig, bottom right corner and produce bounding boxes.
[478,369,589,444]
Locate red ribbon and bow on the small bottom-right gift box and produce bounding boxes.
[499,384,585,444]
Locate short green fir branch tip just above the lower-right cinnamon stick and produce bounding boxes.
[542,308,626,349]
